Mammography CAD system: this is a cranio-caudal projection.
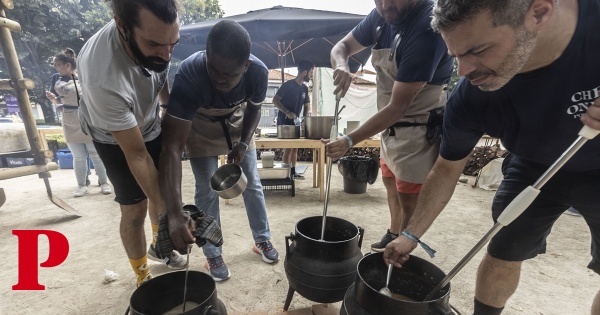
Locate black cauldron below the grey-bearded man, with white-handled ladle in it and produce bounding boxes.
[340,253,454,315]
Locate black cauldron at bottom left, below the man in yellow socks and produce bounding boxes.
[126,270,227,315]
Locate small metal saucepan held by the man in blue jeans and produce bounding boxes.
[210,163,248,199]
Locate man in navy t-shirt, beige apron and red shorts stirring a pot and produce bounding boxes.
[327,0,454,252]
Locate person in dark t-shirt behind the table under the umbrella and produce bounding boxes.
[273,60,315,178]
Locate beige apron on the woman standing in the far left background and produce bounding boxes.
[54,80,92,143]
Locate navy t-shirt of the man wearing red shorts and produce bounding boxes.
[352,1,454,85]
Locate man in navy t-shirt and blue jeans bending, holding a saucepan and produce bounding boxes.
[160,20,279,281]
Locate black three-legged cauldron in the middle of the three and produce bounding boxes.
[283,216,364,311]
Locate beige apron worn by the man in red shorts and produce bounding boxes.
[371,48,445,184]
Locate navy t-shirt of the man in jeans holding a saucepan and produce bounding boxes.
[167,51,268,120]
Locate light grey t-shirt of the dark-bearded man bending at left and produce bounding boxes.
[77,21,168,144]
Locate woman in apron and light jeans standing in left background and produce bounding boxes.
[46,48,112,197]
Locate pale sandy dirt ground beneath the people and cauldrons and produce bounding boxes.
[0,162,599,315]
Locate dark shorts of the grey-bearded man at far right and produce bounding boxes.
[488,154,600,274]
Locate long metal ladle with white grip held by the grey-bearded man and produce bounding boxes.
[424,125,600,301]
